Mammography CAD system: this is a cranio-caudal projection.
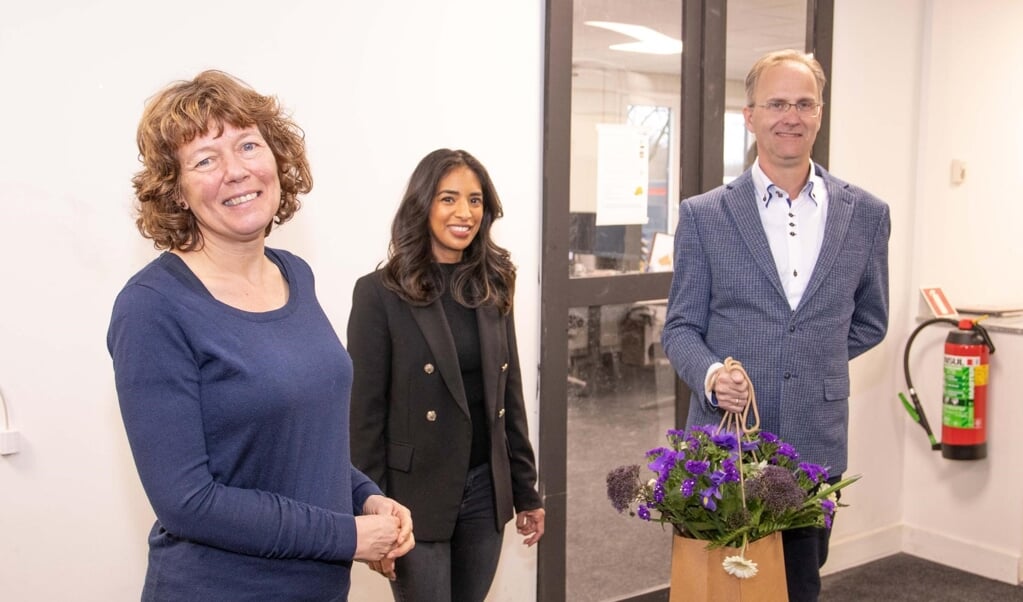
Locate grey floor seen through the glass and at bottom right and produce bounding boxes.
[566,364,1023,602]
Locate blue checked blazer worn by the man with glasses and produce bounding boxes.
[662,165,891,476]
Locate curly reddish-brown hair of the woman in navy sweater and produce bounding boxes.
[132,71,313,251]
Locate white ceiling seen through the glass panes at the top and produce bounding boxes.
[572,0,806,80]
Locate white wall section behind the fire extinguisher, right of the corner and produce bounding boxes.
[903,0,1023,583]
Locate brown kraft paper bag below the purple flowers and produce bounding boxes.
[669,531,789,602]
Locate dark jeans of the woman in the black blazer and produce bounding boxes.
[391,464,504,602]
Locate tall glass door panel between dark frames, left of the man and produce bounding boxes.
[565,0,682,600]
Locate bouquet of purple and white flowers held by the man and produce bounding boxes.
[608,425,859,577]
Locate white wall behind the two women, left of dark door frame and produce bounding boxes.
[0,0,543,602]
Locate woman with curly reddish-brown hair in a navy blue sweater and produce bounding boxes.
[107,71,414,601]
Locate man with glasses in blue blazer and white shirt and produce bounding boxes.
[662,50,891,602]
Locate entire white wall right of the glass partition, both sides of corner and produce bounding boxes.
[826,0,1023,584]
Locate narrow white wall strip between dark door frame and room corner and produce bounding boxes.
[825,0,924,572]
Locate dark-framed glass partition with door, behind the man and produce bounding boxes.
[537,0,831,601]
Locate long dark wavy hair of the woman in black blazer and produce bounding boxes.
[383,148,516,313]
